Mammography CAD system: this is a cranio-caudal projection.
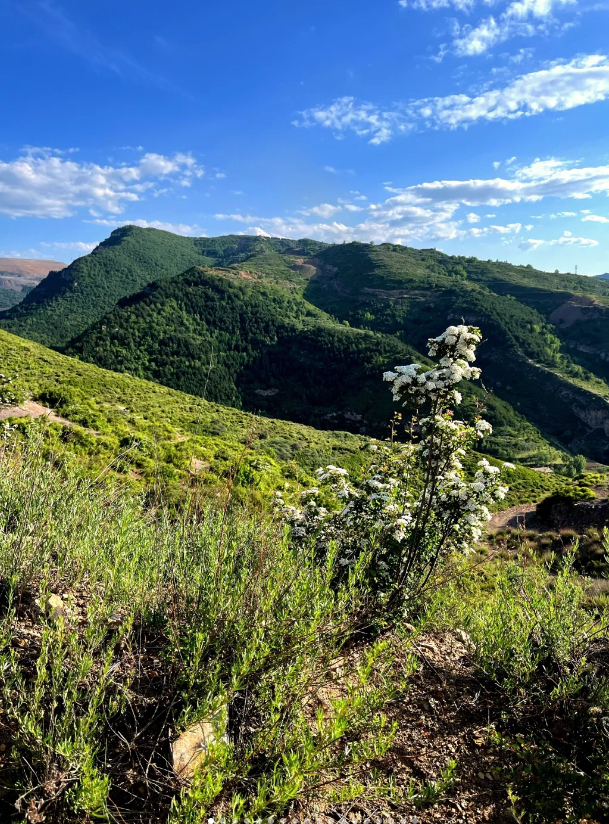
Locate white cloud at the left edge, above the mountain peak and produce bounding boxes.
[0,150,203,218]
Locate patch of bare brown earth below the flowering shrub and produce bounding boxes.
[296,633,514,824]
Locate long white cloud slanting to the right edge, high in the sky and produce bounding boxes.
[294,54,609,142]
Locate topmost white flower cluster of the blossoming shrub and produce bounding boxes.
[383,325,482,406]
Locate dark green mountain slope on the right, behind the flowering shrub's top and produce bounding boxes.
[304,244,609,461]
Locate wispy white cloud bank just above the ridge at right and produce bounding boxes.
[216,159,609,248]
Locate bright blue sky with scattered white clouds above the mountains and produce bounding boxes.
[0,0,609,274]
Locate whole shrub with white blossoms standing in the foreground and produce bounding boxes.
[276,325,513,602]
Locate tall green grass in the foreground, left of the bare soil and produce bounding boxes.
[0,434,400,822]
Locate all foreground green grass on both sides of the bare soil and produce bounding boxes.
[0,440,609,824]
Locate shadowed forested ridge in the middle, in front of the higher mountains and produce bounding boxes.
[66,262,556,459]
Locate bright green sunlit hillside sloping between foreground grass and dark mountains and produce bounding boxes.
[0,331,563,506]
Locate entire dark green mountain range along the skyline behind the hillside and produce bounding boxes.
[0,227,609,465]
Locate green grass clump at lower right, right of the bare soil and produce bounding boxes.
[427,540,609,824]
